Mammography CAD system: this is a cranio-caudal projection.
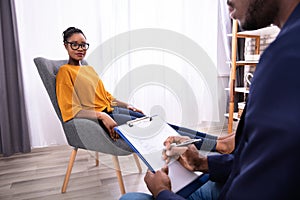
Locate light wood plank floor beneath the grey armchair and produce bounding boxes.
[0,146,149,200]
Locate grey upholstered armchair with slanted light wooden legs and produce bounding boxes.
[34,57,142,194]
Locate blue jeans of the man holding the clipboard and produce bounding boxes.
[120,181,223,200]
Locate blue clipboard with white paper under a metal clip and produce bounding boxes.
[114,115,202,192]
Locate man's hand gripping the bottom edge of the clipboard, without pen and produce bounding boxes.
[144,166,171,198]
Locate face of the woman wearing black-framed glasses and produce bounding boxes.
[65,33,88,62]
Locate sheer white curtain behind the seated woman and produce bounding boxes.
[15,0,229,147]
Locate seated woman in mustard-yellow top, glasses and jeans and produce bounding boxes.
[56,27,234,153]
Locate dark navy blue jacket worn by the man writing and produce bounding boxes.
[157,4,300,200]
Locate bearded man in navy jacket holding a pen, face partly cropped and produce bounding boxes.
[139,0,300,200]
